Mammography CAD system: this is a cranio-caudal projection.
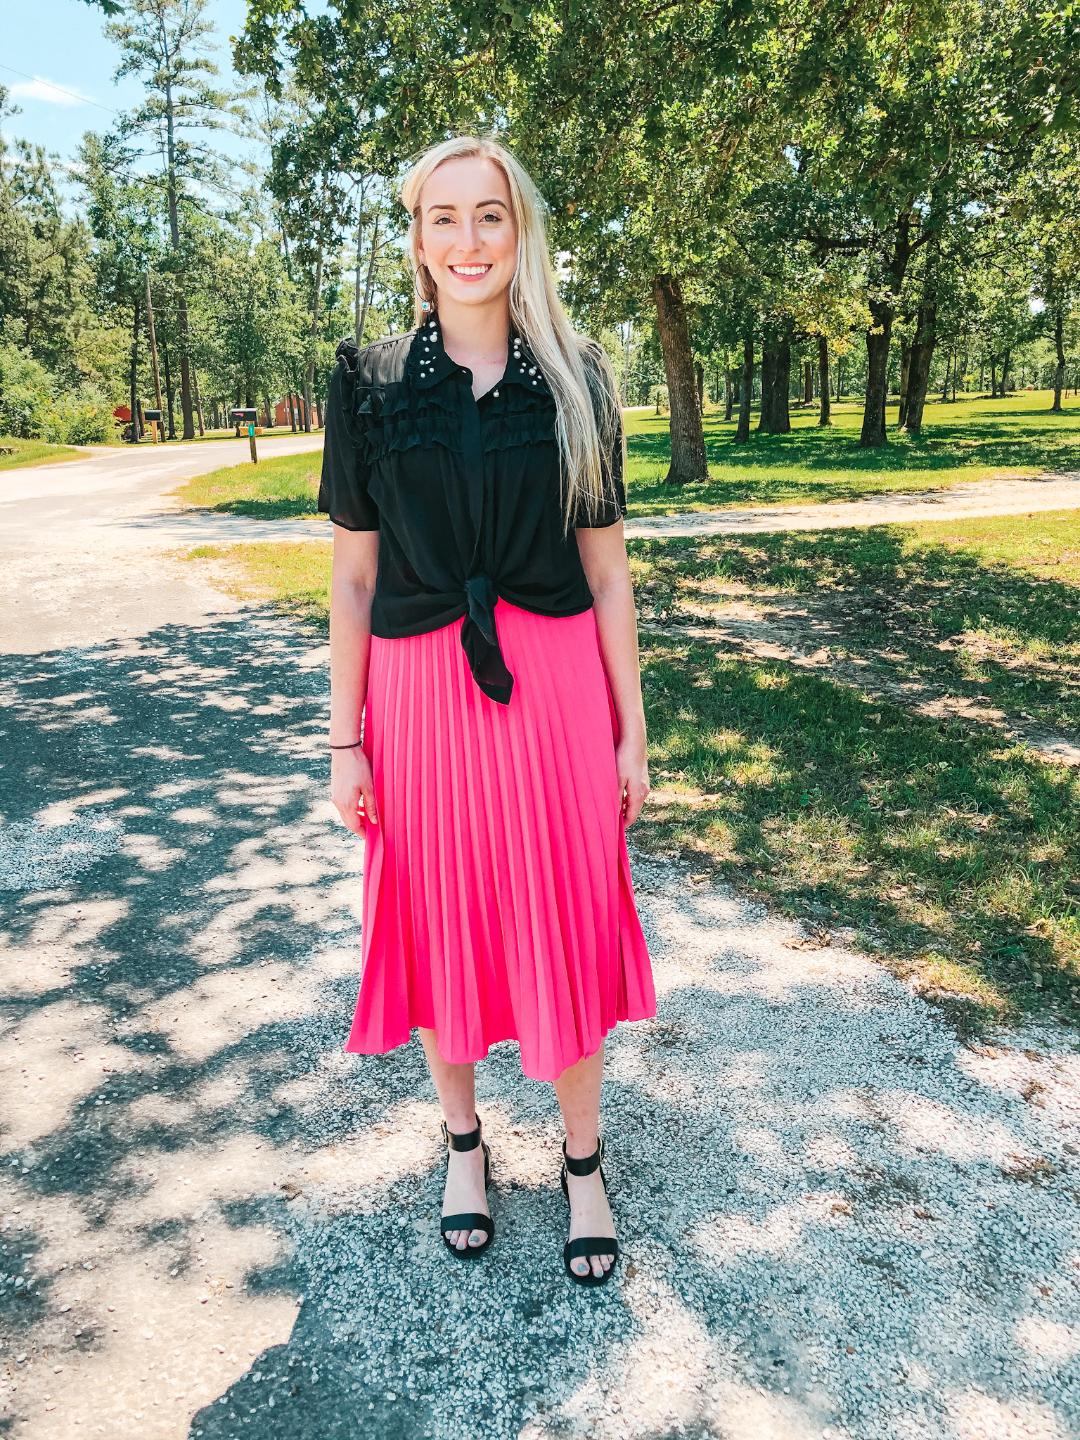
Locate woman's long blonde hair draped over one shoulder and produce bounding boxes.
[399,135,626,533]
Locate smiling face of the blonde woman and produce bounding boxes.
[418,156,517,305]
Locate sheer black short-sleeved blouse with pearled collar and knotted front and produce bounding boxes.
[318,315,626,704]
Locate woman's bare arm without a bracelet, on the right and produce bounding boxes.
[576,518,649,825]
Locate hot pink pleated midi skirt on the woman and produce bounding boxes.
[344,598,657,1080]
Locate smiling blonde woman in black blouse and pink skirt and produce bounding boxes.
[318,137,655,1284]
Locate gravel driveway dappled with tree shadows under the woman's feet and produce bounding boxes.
[0,443,1080,1440]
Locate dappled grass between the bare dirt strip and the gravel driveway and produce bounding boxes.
[639,635,1080,1030]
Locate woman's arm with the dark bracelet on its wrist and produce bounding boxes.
[330,526,379,835]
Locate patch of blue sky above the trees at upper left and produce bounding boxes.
[0,0,254,174]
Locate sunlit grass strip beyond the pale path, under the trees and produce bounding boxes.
[179,390,1080,520]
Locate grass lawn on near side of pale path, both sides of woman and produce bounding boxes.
[182,516,1080,1031]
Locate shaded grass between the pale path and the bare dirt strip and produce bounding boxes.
[632,510,1080,733]
